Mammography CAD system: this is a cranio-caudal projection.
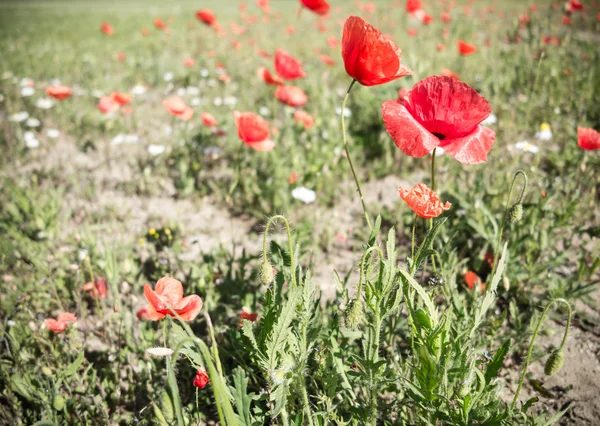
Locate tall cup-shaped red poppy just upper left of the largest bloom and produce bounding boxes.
[342,16,411,86]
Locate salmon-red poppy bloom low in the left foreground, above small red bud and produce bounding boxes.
[144,277,202,321]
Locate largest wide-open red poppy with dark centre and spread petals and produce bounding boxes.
[382,76,496,164]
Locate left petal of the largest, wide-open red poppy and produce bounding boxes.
[381,101,440,157]
